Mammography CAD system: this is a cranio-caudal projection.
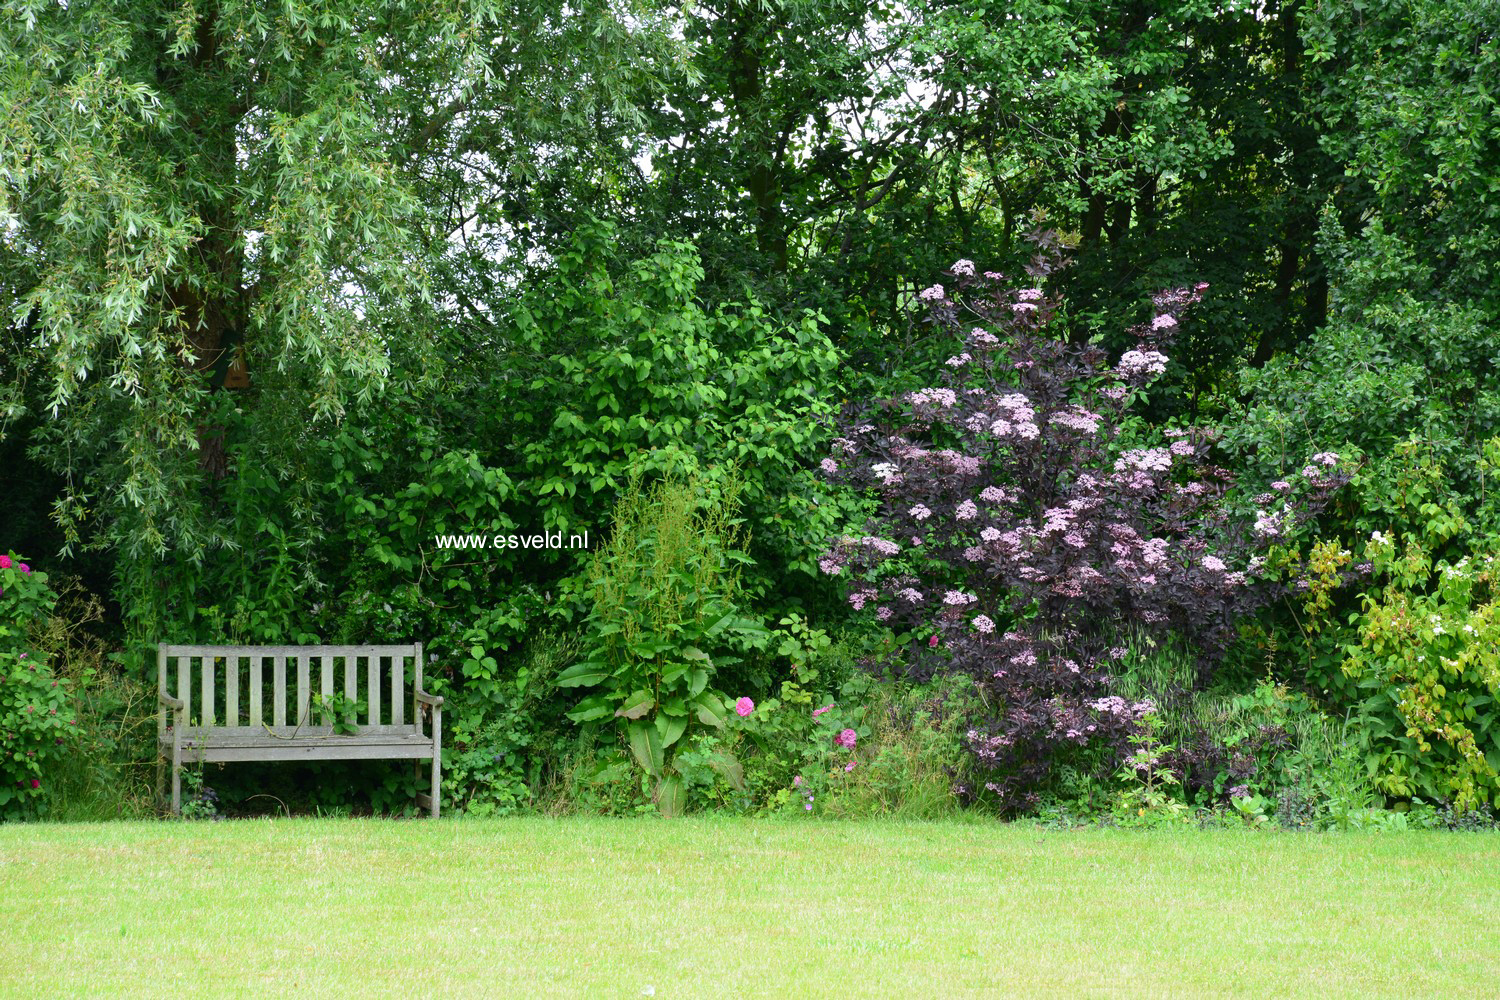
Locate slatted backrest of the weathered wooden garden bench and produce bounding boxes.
[156,642,422,732]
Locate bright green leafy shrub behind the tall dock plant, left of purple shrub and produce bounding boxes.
[497,223,839,597]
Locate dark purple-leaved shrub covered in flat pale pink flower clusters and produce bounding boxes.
[821,234,1347,810]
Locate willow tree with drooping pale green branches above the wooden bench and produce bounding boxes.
[0,0,669,620]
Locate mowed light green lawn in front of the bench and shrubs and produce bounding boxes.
[0,819,1500,997]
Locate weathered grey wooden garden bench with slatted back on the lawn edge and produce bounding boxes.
[156,642,443,817]
